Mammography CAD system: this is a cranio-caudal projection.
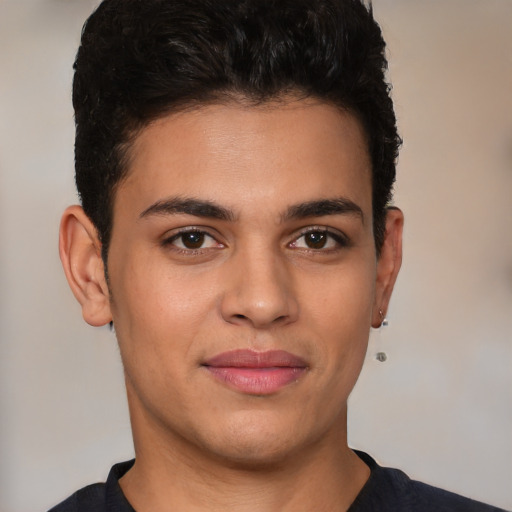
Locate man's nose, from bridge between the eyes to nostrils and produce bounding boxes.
[221,247,299,329]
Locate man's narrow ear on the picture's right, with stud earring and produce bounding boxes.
[372,207,404,327]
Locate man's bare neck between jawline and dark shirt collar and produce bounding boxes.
[120,400,370,512]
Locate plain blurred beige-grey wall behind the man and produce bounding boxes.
[0,0,512,512]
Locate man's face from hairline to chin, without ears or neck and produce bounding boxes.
[104,100,398,463]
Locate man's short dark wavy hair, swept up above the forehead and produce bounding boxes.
[73,0,401,262]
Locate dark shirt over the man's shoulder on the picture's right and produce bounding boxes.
[349,452,505,512]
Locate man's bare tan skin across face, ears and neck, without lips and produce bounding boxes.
[60,99,403,512]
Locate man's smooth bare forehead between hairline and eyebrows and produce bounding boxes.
[114,100,371,218]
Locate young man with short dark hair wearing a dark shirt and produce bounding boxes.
[53,0,506,512]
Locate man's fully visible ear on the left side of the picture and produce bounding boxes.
[59,206,112,327]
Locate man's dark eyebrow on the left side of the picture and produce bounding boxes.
[139,197,235,221]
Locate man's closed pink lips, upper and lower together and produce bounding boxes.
[203,350,308,395]
